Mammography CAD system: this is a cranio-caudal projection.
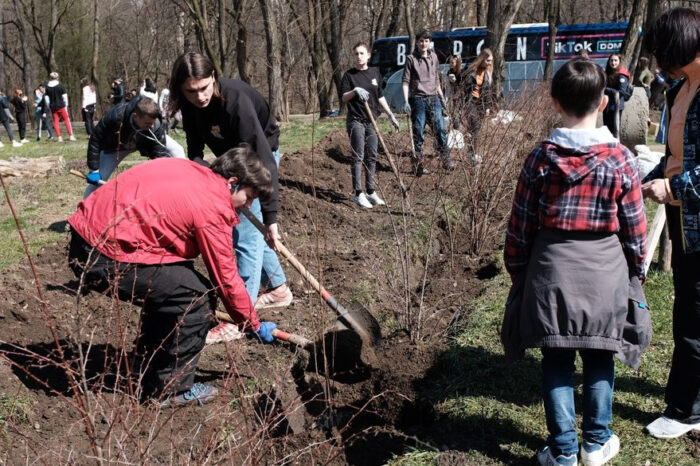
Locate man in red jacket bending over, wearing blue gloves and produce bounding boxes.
[68,147,276,405]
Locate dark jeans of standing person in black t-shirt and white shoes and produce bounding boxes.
[347,120,378,192]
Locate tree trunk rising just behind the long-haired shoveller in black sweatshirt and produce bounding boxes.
[259,0,286,120]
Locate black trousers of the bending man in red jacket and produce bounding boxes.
[68,232,216,397]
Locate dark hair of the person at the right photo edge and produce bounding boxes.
[644,8,700,71]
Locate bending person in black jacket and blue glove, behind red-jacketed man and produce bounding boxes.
[83,96,185,199]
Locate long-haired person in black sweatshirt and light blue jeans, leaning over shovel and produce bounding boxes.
[169,52,293,343]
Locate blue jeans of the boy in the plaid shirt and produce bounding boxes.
[542,348,615,456]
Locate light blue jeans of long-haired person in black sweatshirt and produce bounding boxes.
[233,150,287,303]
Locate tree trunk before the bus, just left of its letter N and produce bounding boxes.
[486,0,522,92]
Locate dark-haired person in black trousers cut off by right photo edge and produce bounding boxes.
[642,8,700,438]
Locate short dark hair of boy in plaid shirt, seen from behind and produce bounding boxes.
[551,58,605,118]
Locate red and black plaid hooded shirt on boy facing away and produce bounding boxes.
[504,142,647,279]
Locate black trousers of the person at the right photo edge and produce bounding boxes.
[665,206,700,424]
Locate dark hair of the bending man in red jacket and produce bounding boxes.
[210,144,273,201]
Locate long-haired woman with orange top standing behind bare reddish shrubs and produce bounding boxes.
[464,48,493,162]
